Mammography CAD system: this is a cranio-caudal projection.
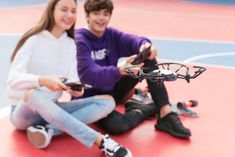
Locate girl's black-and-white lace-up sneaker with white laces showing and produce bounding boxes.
[100,135,132,157]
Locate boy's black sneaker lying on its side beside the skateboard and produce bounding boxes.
[125,101,157,119]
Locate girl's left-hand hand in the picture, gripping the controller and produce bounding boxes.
[39,76,69,92]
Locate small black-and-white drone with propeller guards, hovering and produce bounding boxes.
[125,62,206,84]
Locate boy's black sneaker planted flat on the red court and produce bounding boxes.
[155,112,191,138]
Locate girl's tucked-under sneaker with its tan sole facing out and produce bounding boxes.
[27,125,53,149]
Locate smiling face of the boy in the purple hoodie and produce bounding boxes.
[86,9,111,37]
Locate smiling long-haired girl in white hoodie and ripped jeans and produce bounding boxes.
[7,0,131,157]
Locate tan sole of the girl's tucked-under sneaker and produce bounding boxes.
[27,127,50,149]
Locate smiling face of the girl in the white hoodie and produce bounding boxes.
[53,0,77,32]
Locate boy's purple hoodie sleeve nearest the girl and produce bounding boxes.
[77,41,121,90]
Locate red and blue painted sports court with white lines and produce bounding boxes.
[0,0,235,157]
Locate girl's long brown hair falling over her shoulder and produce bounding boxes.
[11,0,77,61]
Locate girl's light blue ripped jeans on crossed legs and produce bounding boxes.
[11,89,115,147]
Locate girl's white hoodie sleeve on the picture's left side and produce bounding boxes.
[7,37,39,90]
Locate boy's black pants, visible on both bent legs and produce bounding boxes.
[96,60,169,134]
